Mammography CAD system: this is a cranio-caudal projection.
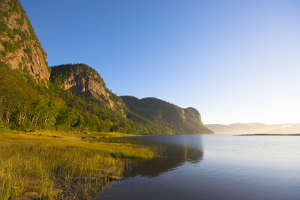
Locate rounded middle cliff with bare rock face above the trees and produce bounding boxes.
[50,64,125,113]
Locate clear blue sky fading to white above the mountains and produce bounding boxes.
[21,0,300,123]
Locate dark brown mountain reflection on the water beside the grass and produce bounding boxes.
[125,136,204,177]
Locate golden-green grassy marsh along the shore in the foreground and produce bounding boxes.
[0,130,154,200]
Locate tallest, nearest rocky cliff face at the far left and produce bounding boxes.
[0,0,50,82]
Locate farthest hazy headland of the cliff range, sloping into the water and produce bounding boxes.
[121,96,212,133]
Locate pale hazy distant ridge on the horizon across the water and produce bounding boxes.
[205,123,300,134]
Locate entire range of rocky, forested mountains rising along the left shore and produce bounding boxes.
[0,0,210,134]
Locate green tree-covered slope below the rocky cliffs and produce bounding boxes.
[0,63,167,134]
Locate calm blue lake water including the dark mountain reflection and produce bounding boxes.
[97,135,300,200]
